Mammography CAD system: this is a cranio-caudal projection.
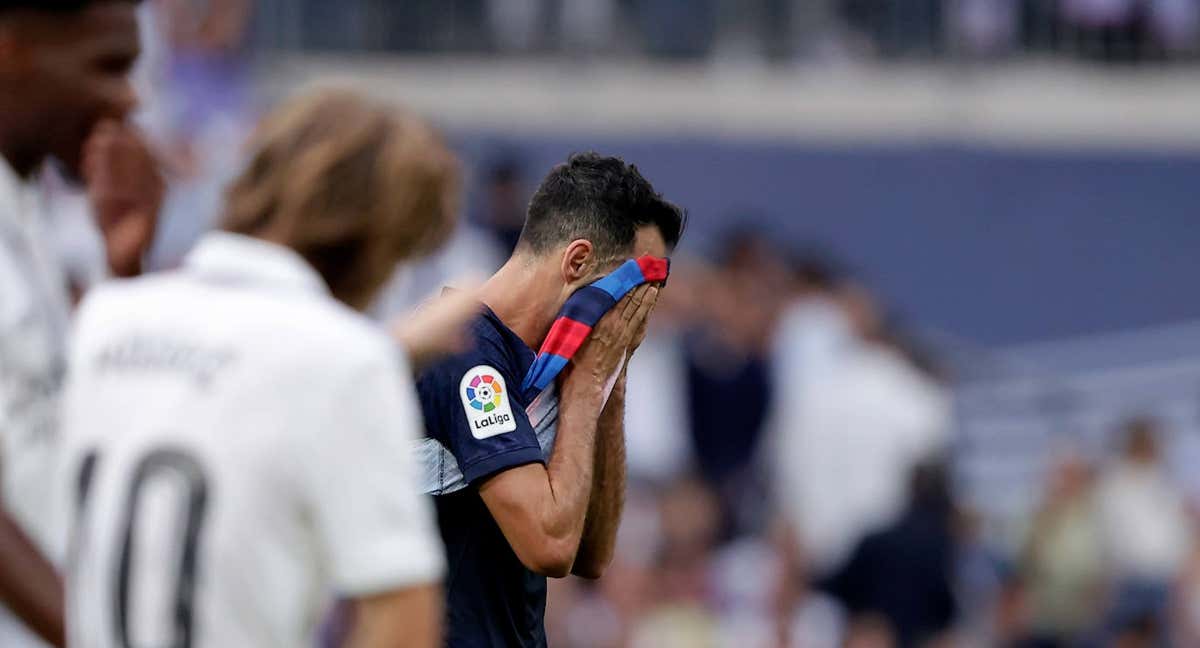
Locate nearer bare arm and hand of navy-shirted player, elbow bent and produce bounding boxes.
[479,288,649,578]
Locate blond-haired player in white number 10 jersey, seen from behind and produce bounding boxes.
[59,91,473,648]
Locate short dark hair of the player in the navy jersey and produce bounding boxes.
[517,152,688,259]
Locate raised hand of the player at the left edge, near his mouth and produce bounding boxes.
[83,120,166,277]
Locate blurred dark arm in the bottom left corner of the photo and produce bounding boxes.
[0,510,66,646]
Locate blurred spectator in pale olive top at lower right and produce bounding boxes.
[1022,456,1105,648]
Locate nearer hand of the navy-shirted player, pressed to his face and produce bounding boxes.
[565,284,659,389]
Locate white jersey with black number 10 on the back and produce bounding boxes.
[55,233,444,648]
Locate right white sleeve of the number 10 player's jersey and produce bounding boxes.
[304,355,445,596]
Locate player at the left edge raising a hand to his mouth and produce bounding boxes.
[0,0,163,646]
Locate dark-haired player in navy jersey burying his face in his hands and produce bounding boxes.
[418,154,684,647]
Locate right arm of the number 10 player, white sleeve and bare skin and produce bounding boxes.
[314,355,445,648]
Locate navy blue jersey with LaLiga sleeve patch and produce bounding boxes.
[418,310,546,648]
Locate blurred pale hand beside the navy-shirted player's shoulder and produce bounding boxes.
[391,289,482,372]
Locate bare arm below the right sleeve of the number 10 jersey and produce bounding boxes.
[346,586,442,648]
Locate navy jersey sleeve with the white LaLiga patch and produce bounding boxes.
[418,341,545,484]
